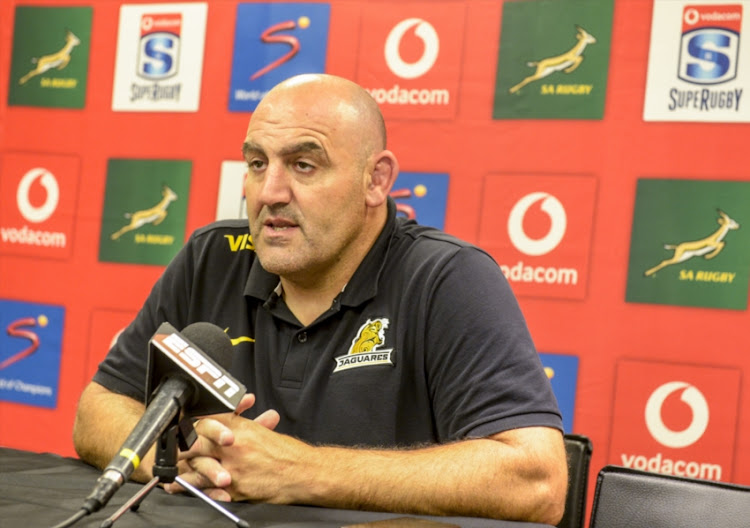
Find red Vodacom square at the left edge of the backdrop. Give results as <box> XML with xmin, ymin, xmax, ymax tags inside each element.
<box><xmin>0</xmin><ymin>153</ymin><xmax>80</xmax><ymax>258</ymax></box>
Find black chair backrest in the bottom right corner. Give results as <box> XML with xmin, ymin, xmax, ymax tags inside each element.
<box><xmin>589</xmin><ymin>466</ymin><xmax>750</xmax><ymax>528</ymax></box>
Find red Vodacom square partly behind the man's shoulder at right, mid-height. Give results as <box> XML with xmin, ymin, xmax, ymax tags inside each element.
<box><xmin>477</xmin><ymin>174</ymin><xmax>596</xmax><ymax>299</ymax></box>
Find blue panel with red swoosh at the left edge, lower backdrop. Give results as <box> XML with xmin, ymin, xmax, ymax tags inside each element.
<box><xmin>0</xmin><ymin>300</ymin><xmax>65</xmax><ymax>409</ymax></box>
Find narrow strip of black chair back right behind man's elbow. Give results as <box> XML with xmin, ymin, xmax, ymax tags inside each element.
<box><xmin>557</xmin><ymin>433</ymin><xmax>593</xmax><ymax>528</ymax></box>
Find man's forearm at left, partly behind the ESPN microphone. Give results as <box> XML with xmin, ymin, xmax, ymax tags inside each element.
<box><xmin>73</xmin><ymin>382</ymin><xmax>154</xmax><ymax>482</ymax></box>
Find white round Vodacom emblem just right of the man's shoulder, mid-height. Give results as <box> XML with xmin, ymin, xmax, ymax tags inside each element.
<box><xmin>508</xmin><ymin>192</ymin><xmax>568</xmax><ymax>256</ymax></box>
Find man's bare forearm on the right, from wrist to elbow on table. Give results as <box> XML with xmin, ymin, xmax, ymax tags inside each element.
<box><xmin>251</xmin><ymin>428</ymin><xmax>567</xmax><ymax>524</ymax></box>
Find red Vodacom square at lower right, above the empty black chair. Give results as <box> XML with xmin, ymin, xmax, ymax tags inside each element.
<box><xmin>608</xmin><ymin>360</ymin><xmax>741</xmax><ymax>481</ymax></box>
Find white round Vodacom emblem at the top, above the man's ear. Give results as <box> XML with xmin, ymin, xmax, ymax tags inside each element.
<box><xmin>385</xmin><ymin>18</ymin><xmax>440</xmax><ymax>79</ymax></box>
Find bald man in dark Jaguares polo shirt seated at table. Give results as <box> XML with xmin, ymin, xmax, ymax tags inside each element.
<box><xmin>74</xmin><ymin>75</ymin><xmax>567</xmax><ymax>524</ymax></box>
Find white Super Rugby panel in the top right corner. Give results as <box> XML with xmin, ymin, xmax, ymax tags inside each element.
<box><xmin>643</xmin><ymin>0</ymin><xmax>750</xmax><ymax>122</ymax></box>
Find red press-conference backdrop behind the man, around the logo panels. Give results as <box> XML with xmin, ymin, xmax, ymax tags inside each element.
<box><xmin>0</xmin><ymin>0</ymin><xmax>750</xmax><ymax>520</ymax></box>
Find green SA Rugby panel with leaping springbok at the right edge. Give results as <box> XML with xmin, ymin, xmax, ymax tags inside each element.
<box><xmin>626</xmin><ymin>179</ymin><xmax>750</xmax><ymax>310</ymax></box>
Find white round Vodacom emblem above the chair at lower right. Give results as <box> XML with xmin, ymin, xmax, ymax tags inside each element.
<box><xmin>646</xmin><ymin>381</ymin><xmax>708</xmax><ymax>447</ymax></box>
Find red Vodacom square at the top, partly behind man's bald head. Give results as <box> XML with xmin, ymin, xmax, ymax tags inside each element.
<box><xmin>357</xmin><ymin>2</ymin><xmax>466</xmax><ymax>119</ymax></box>
